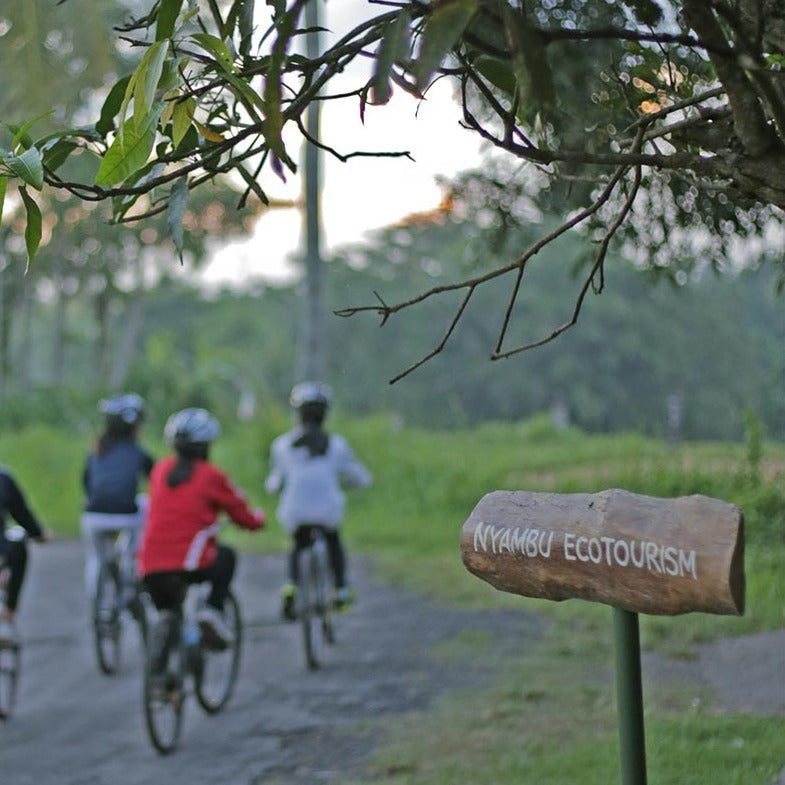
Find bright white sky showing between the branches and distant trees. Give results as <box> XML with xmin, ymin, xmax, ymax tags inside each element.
<box><xmin>203</xmin><ymin>0</ymin><xmax>481</xmax><ymax>286</ymax></box>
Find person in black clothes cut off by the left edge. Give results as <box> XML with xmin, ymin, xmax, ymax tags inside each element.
<box><xmin>0</xmin><ymin>466</ymin><xmax>52</xmax><ymax>645</ymax></box>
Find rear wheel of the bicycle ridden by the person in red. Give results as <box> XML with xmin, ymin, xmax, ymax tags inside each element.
<box><xmin>144</xmin><ymin>620</ymin><xmax>185</xmax><ymax>755</ymax></box>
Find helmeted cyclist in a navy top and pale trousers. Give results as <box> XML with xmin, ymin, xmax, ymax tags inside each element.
<box><xmin>81</xmin><ymin>393</ymin><xmax>153</xmax><ymax>600</ymax></box>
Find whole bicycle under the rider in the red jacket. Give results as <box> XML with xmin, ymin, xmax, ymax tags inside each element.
<box><xmin>144</xmin><ymin>584</ymin><xmax>242</xmax><ymax>755</ymax></box>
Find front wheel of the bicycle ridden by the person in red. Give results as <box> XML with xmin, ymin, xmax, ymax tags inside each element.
<box><xmin>193</xmin><ymin>592</ymin><xmax>243</xmax><ymax>714</ymax></box>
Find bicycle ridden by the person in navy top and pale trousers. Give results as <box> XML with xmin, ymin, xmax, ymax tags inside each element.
<box><xmin>92</xmin><ymin>529</ymin><xmax>149</xmax><ymax>676</ymax></box>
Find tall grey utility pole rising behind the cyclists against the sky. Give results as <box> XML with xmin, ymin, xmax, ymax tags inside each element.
<box><xmin>297</xmin><ymin>0</ymin><xmax>327</xmax><ymax>381</ymax></box>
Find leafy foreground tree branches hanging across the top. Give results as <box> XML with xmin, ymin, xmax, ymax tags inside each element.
<box><xmin>0</xmin><ymin>0</ymin><xmax>785</xmax><ymax>374</ymax></box>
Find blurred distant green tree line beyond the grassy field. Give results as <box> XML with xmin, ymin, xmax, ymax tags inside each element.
<box><xmin>0</xmin><ymin>208</ymin><xmax>785</xmax><ymax>439</ymax></box>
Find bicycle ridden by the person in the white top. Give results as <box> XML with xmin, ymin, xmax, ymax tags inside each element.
<box><xmin>295</xmin><ymin>525</ymin><xmax>335</xmax><ymax>670</ymax></box>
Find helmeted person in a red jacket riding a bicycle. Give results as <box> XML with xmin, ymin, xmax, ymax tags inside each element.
<box><xmin>138</xmin><ymin>409</ymin><xmax>265</xmax><ymax>652</ymax></box>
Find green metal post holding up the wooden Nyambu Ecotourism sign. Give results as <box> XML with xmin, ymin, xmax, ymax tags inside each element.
<box><xmin>613</xmin><ymin>608</ymin><xmax>646</xmax><ymax>785</ymax></box>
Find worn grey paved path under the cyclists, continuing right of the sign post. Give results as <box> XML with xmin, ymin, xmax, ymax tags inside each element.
<box><xmin>0</xmin><ymin>541</ymin><xmax>785</xmax><ymax>785</ymax></box>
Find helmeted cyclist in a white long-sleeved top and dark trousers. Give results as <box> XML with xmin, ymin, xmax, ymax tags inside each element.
<box><xmin>265</xmin><ymin>381</ymin><xmax>372</xmax><ymax>620</ymax></box>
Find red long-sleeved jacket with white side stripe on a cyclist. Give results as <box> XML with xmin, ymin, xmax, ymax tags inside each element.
<box><xmin>138</xmin><ymin>455</ymin><xmax>265</xmax><ymax>575</ymax></box>
